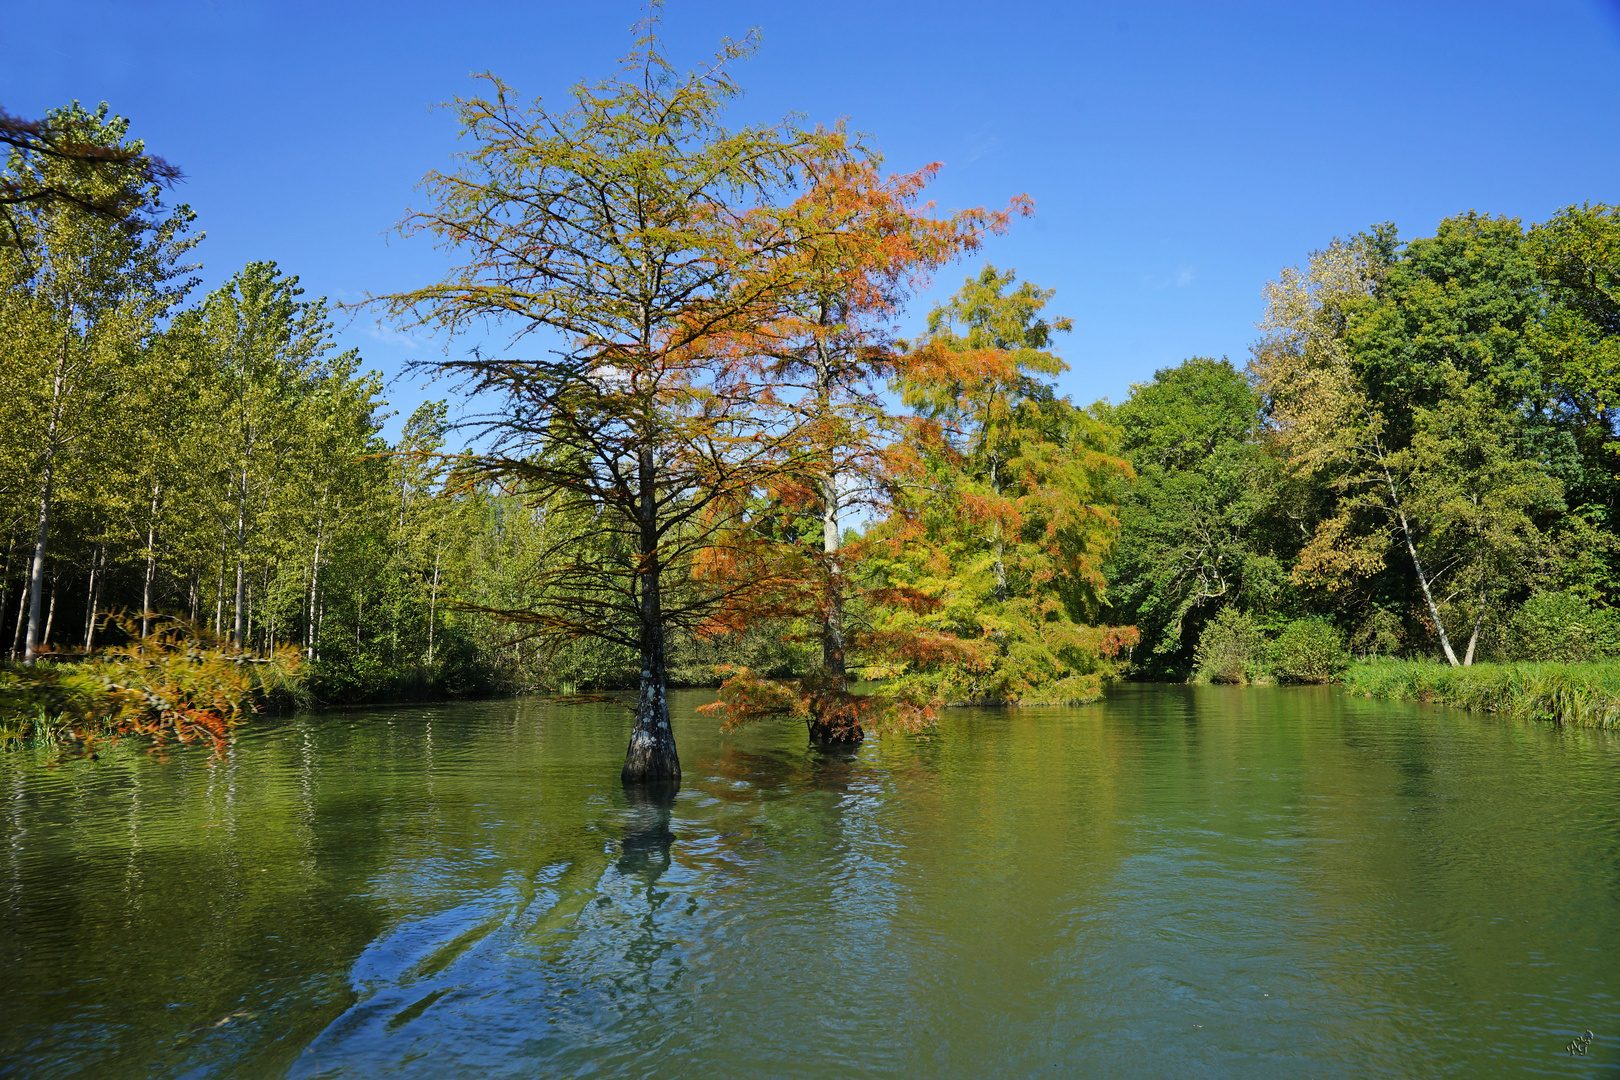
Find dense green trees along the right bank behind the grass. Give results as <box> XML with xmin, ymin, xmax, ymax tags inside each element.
<box><xmin>1097</xmin><ymin>206</ymin><xmax>1620</xmax><ymax>675</ymax></box>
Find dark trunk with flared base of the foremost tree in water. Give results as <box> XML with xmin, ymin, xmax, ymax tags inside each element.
<box><xmin>619</xmin><ymin>445</ymin><xmax>680</xmax><ymax>784</ymax></box>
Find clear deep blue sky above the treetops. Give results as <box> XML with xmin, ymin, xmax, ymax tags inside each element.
<box><xmin>0</xmin><ymin>0</ymin><xmax>1620</xmax><ymax>431</ymax></box>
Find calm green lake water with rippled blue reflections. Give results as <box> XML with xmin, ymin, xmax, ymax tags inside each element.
<box><xmin>0</xmin><ymin>687</ymin><xmax>1620</xmax><ymax>1080</ymax></box>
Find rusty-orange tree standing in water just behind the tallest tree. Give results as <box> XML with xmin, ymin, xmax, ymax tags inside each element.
<box><xmin>706</xmin><ymin>166</ymin><xmax>1030</xmax><ymax>743</ymax></box>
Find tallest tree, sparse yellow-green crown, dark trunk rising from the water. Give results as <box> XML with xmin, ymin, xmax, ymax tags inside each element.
<box><xmin>381</xmin><ymin>18</ymin><xmax>860</xmax><ymax>780</ymax></box>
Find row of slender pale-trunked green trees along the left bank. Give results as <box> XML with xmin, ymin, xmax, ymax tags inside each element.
<box><xmin>0</xmin><ymin>104</ymin><xmax>622</xmax><ymax>699</ymax></box>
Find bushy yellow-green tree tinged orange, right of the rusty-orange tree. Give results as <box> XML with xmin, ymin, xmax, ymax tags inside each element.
<box><xmin>888</xmin><ymin>266</ymin><xmax>1137</xmax><ymax>704</ymax></box>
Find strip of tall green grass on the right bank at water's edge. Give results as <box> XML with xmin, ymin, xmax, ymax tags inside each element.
<box><xmin>1345</xmin><ymin>661</ymin><xmax>1620</xmax><ymax>727</ymax></box>
